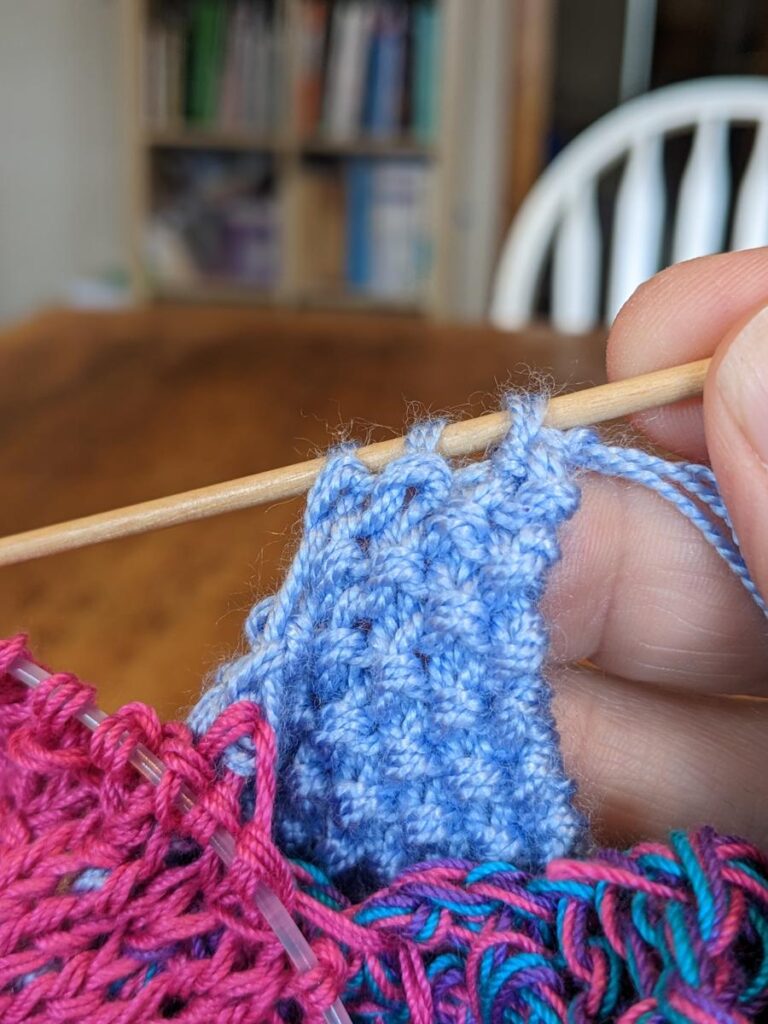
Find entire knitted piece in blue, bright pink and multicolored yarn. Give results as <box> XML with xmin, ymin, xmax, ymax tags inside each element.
<box><xmin>0</xmin><ymin>397</ymin><xmax>768</xmax><ymax>1024</ymax></box>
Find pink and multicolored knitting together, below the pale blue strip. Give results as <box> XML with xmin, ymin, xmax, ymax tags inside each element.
<box><xmin>0</xmin><ymin>638</ymin><xmax>768</xmax><ymax>1024</ymax></box>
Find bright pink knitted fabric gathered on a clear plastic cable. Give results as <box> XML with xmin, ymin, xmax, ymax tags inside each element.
<box><xmin>0</xmin><ymin>637</ymin><xmax>325</xmax><ymax>1024</ymax></box>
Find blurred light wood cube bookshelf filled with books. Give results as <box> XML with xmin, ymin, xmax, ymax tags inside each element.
<box><xmin>122</xmin><ymin>0</ymin><xmax>514</xmax><ymax>316</ymax></box>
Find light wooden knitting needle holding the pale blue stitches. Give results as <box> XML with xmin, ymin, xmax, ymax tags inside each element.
<box><xmin>0</xmin><ymin>359</ymin><xmax>710</xmax><ymax>565</ymax></box>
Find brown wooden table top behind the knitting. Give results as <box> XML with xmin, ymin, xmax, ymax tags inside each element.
<box><xmin>0</xmin><ymin>307</ymin><xmax>604</xmax><ymax>716</ymax></box>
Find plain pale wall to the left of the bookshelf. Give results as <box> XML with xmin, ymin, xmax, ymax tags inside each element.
<box><xmin>0</xmin><ymin>0</ymin><xmax>127</xmax><ymax>321</ymax></box>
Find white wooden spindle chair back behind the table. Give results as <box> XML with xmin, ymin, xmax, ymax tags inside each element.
<box><xmin>490</xmin><ymin>78</ymin><xmax>768</xmax><ymax>333</ymax></box>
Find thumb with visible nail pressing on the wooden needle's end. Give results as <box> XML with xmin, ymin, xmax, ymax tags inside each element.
<box><xmin>705</xmin><ymin>306</ymin><xmax>768</xmax><ymax>599</ymax></box>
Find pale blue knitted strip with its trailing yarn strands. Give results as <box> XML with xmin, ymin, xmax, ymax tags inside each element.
<box><xmin>190</xmin><ymin>396</ymin><xmax>760</xmax><ymax>884</ymax></box>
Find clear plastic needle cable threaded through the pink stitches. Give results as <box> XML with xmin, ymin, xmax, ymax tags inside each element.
<box><xmin>10</xmin><ymin>658</ymin><xmax>351</xmax><ymax>1024</ymax></box>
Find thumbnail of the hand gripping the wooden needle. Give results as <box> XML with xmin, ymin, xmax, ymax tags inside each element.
<box><xmin>717</xmin><ymin>306</ymin><xmax>768</xmax><ymax>464</ymax></box>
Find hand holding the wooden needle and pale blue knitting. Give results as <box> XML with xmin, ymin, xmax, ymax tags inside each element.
<box><xmin>545</xmin><ymin>249</ymin><xmax>768</xmax><ymax>847</ymax></box>
